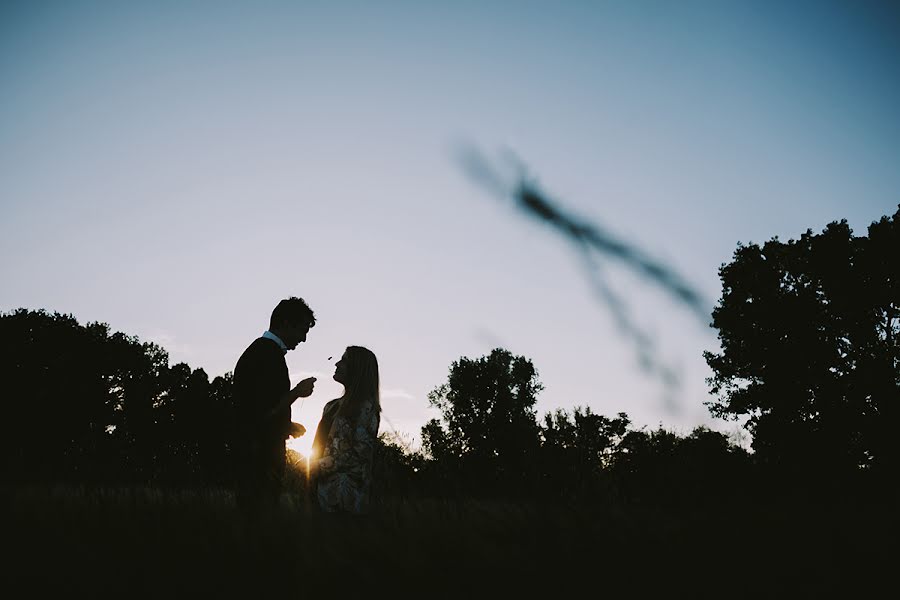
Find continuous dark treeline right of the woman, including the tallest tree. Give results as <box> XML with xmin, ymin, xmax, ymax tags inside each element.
<box><xmin>376</xmin><ymin>210</ymin><xmax>900</xmax><ymax>502</ymax></box>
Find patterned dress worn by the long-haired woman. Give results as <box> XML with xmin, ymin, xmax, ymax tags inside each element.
<box><xmin>317</xmin><ymin>401</ymin><xmax>381</xmax><ymax>514</ymax></box>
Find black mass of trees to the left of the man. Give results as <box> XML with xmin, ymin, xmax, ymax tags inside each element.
<box><xmin>0</xmin><ymin>309</ymin><xmax>231</xmax><ymax>484</ymax></box>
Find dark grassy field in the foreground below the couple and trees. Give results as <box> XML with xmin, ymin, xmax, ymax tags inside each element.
<box><xmin>0</xmin><ymin>487</ymin><xmax>900</xmax><ymax>598</ymax></box>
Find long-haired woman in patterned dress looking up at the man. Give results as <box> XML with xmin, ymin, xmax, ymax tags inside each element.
<box><xmin>310</xmin><ymin>346</ymin><xmax>381</xmax><ymax>514</ymax></box>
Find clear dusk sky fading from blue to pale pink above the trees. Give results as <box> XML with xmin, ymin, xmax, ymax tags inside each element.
<box><xmin>0</xmin><ymin>0</ymin><xmax>900</xmax><ymax>445</ymax></box>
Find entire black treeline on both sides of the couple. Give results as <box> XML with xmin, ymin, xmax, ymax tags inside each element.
<box><xmin>0</xmin><ymin>210</ymin><xmax>900</xmax><ymax>502</ymax></box>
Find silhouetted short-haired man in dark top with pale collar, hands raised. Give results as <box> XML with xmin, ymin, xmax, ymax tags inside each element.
<box><xmin>234</xmin><ymin>297</ymin><xmax>316</xmax><ymax>517</ymax></box>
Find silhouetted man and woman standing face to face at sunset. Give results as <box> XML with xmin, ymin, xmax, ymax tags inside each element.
<box><xmin>233</xmin><ymin>297</ymin><xmax>381</xmax><ymax>516</ymax></box>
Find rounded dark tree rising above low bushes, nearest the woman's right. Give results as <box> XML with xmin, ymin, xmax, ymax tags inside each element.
<box><xmin>422</xmin><ymin>348</ymin><xmax>543</xmax><ymax>489</ymax></box>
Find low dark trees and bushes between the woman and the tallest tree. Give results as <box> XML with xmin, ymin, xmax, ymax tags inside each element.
<box><xmin>416</xmin><ymin>349</ymin><xmax>753</xmax><ymax>504</ymax></box>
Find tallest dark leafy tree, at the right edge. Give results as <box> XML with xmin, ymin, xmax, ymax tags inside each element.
<box><xmin>704</xmin><ymin>210</ymin><xmax>900</xmax><ymax>472</ymax></box>
